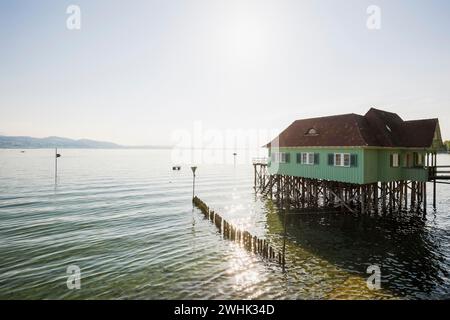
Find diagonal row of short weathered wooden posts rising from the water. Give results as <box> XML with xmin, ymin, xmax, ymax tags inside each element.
<box><xmin>193</xmin><ymin>196</ymin><xmax>285</xmax><ymax>266</ymax></box>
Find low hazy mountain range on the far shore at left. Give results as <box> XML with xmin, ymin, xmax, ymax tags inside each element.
<box><xmin>0</xmin><ymin>136</ymin><xmax>170</xmax><ymax>149</ymax></box>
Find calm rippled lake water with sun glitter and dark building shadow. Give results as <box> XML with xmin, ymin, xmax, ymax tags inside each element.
<box><xmin>0</xmin><ymin>150</ymin><xmax>450</xmax><ymax>299</ymax></box>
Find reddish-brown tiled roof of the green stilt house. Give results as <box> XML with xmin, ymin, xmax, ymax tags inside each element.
<box><xmin>267</xmin><ymin>108</ymin><xmax>438</xmax><ymax>148</ymax></box>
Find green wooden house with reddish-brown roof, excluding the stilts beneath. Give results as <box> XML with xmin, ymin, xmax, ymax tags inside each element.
<box><xmin>267</xmin><ymin>108</ymin><xmax>443</xmax><ymax>184</ymax></box>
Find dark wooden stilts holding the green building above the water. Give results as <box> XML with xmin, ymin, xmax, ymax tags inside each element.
<box><xmin>255</xmin><ymin>164</ymin><xmax>436</xmax><ymax>216</ymax></box>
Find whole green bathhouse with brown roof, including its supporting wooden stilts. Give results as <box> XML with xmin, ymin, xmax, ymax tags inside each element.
<box><xmin>255</xmin><ymin>108</ymin><xmax>443</xmax><ymax>215</ymax></box>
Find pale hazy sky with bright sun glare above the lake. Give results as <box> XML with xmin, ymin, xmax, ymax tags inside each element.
<box><xmin>0</xmin><ymin>0</ymin><xmax>450</xmax><ymax>144</ymax></box>
